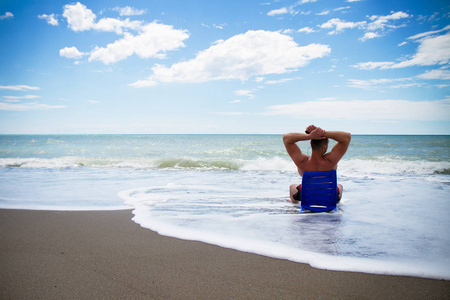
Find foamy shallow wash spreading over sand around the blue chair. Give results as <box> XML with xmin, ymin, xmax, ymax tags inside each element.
<box><xmin>121</xmin><ymin>171</ymin><xmax>450</xmax><ymax>280</ymax></box>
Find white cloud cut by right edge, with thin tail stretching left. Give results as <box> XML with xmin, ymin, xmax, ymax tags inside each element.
<box><xmin>353</xmin><ymin>33</ymin><xmax>450</xmax><ymax>70</ymax></box>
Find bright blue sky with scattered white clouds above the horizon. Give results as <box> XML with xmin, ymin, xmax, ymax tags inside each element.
<box><xmin>0</xmin><ymin>0</ymin><xmax>450</xmax><ymax>134</ymax></box>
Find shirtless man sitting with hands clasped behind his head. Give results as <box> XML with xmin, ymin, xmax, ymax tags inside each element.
<box><xmin>283</xmin><ymin>125</ymin><xmax>351</xmax><ymax>203</ymax></box>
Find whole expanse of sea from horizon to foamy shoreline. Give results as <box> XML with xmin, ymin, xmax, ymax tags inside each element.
<box><xmin>0</xmin><ymin>135</ymin><xmax>450</xmax><ymax>280</ymax></box>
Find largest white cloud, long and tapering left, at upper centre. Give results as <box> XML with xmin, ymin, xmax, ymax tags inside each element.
<box><xmin>131</xmin><ymin>30</ymin><xmax>331</xmax><ymax>87</ymax></box>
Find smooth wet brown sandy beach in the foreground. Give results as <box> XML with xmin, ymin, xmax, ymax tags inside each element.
<box><xmin>0</xmin><ymin>210</ymin><xmax>450</xmax><ymax>299</ymax></box>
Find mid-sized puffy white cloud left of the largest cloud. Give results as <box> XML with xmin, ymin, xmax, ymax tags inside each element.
<box><xmin>89</xmin><ymin>22</ymin><xmax>189</xmax><ymax>64</ymax></box>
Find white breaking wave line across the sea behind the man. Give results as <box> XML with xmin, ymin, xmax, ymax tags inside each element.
<box><xmin>0</xmin><ymin>156</ymin><xmax>450</xmax><ymax>177</ymax></box>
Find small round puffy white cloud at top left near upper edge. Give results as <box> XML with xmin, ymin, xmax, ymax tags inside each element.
<box><xmin>63</xmin><ymin>2</ymin><xmax>96</xmax><ymax>31</ymax></box>
